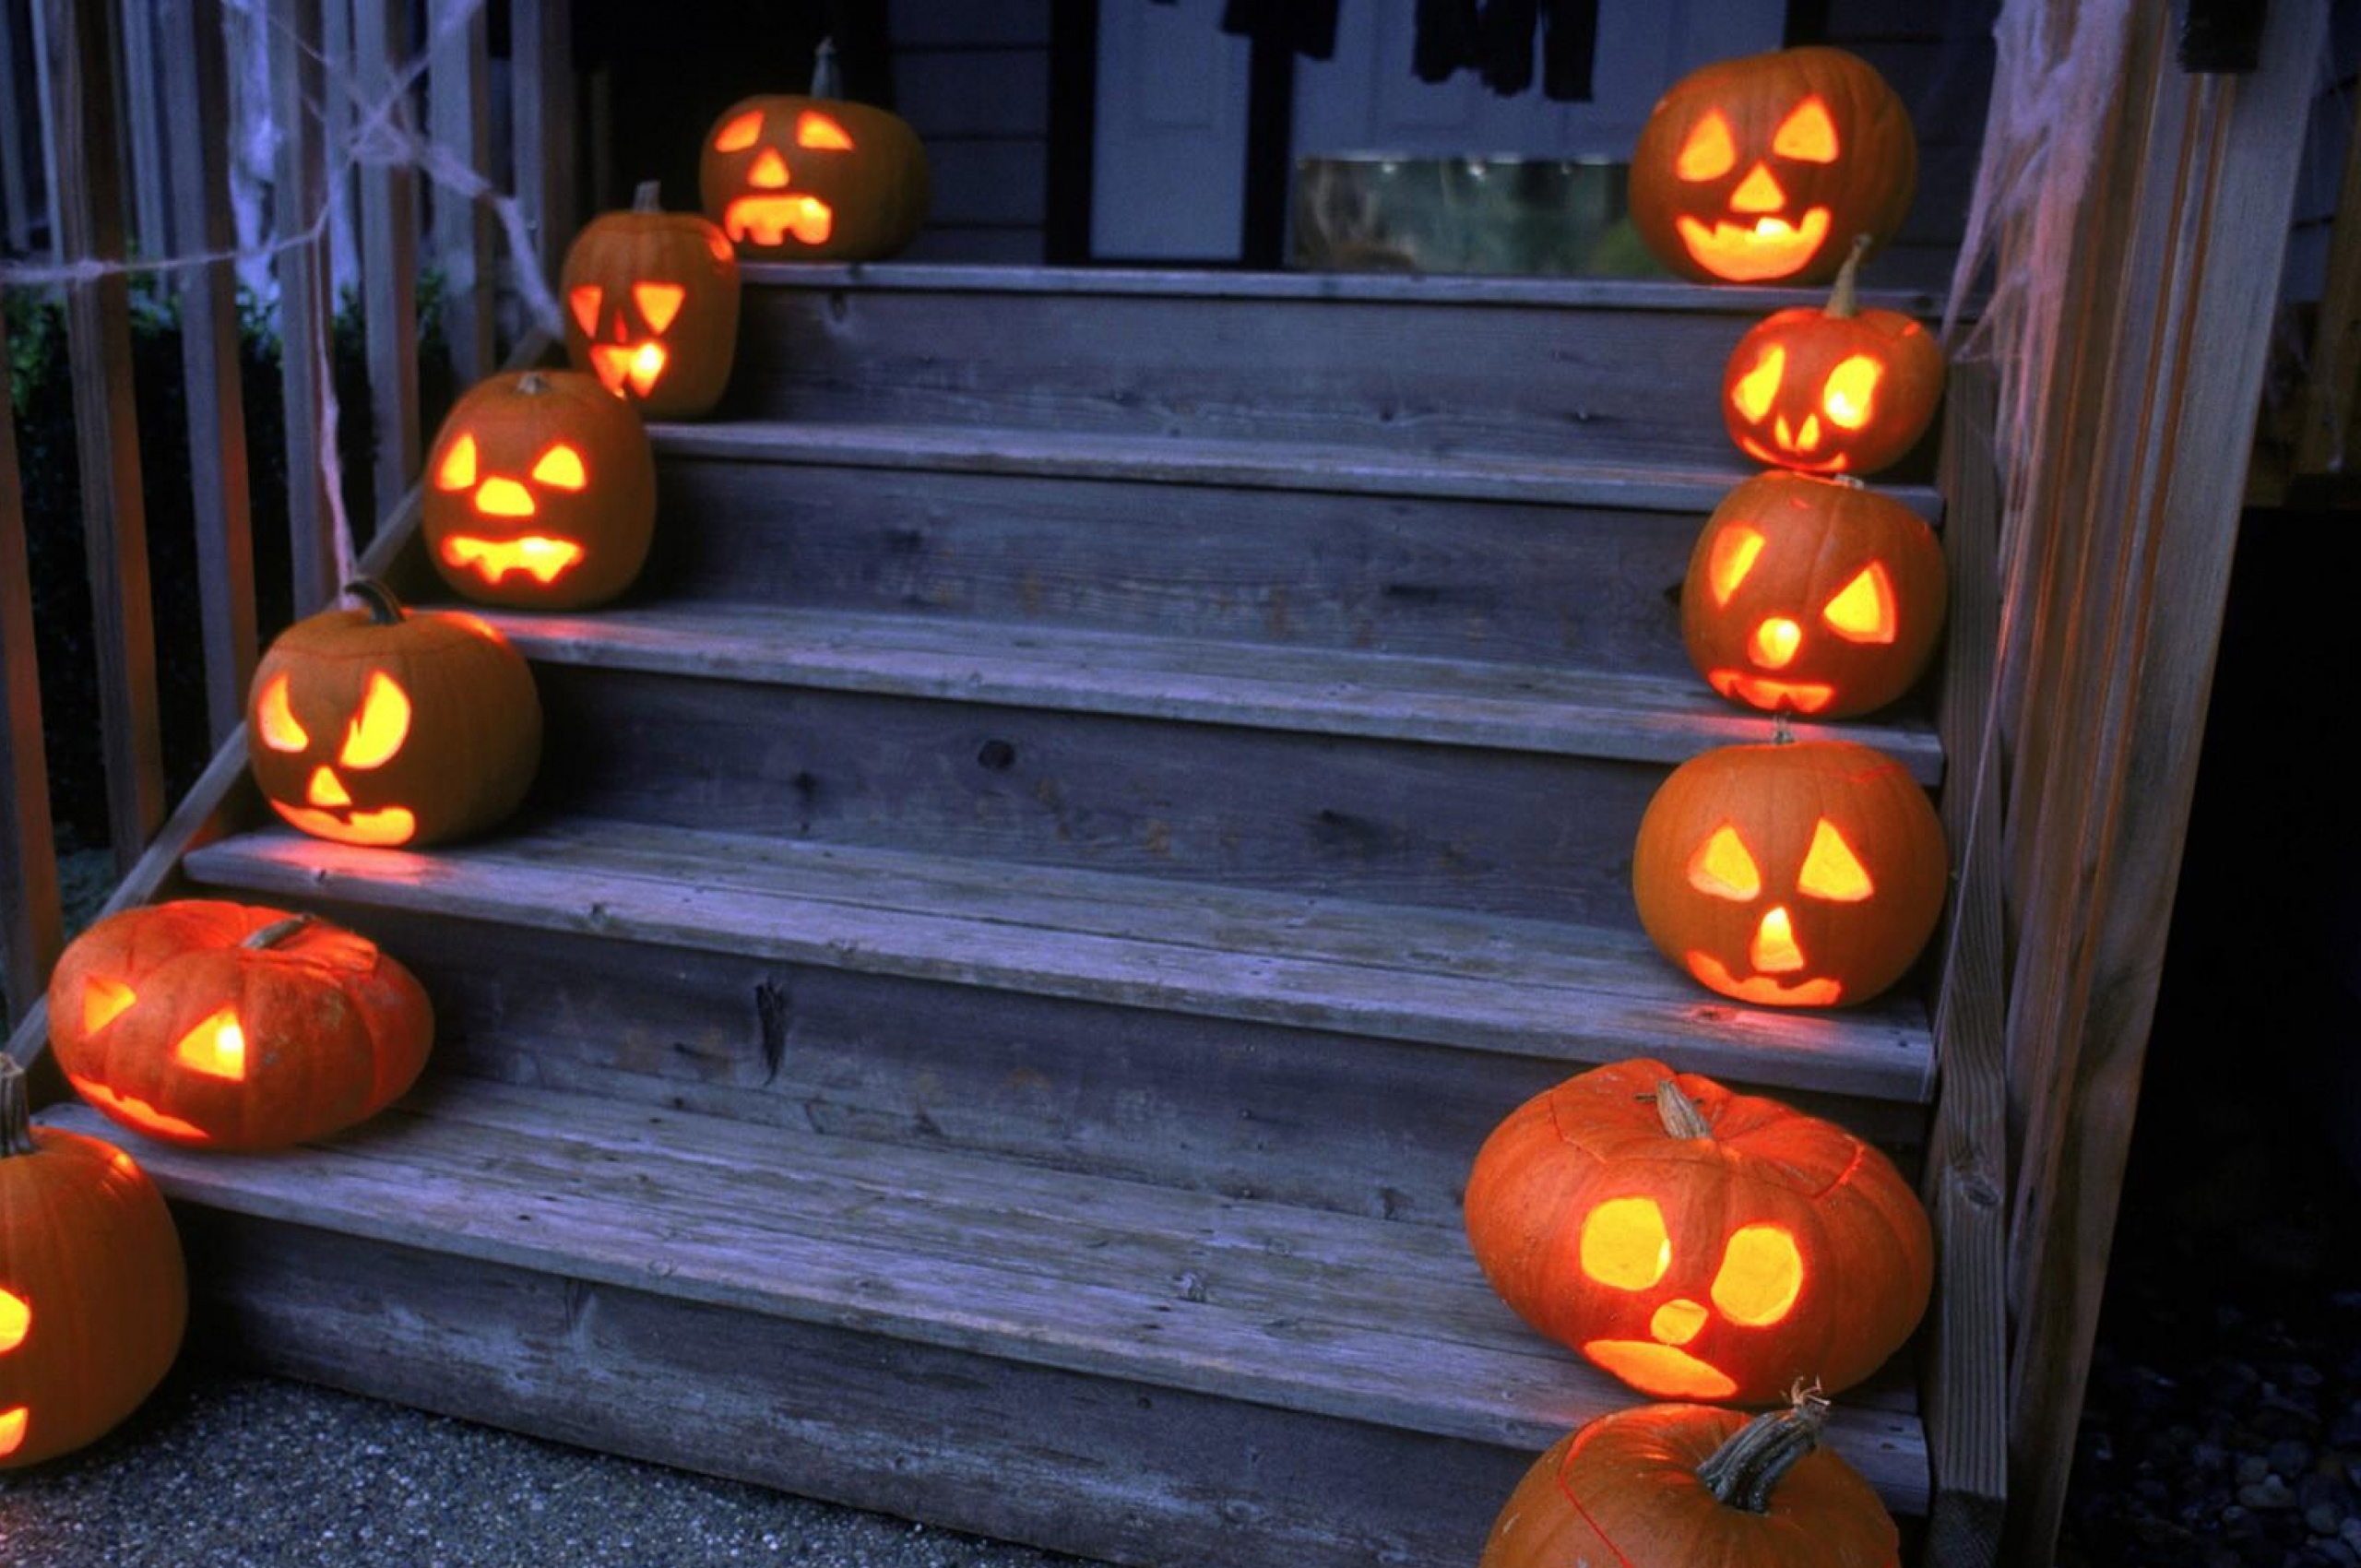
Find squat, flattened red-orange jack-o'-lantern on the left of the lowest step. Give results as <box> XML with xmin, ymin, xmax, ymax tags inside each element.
<box><xmin>50</xmin><ymin>899</ymin><xmax>434</xmax><ymax>1150</ymax></box>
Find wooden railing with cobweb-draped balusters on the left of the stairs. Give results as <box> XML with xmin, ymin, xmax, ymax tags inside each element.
<box><xmin>0</xmin><ymin>0</ymin><xmax>574</xmax><ymax>1028</ymax></box>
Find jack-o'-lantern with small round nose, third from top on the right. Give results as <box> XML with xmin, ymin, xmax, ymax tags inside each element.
<box><xmin>1681</xmin><ymin>469</ymin><xmax>1948</xmax><ymax>718</ymax></box>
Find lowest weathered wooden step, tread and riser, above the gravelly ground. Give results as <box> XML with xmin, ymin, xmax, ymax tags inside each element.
<box><xmin>28</xmin><ymin>1082</ymin><xmax>1929</xmax><ymax>1568</ymax></box>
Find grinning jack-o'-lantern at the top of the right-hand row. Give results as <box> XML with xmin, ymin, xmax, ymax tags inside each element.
<box><xmin>1629</xmin><ymin>45</ymin><xmax>1917</xmax><ymax>283</ymax></box>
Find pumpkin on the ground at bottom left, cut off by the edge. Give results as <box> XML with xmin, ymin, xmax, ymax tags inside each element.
<box><xmin>0</xmin><ymin>1055</ymin><xmax>189</xmax><ymax>1468</ymax></box>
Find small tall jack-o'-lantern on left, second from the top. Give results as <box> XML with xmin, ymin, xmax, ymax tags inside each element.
<box><xmin>557</xmin><ymin>180</ymin><xmax>739</xmax><ymax>421</ymax></box>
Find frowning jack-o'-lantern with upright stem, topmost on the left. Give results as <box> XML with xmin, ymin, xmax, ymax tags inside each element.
<box><xmin>696</xmin><ymin>42</ymin><xmax>928</xmax><ymax>262</ymax></box>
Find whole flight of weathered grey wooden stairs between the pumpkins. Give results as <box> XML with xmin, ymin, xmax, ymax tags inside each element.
<box><xmin>47</xmin><ymin>267</ymin><xmax>1943</xmax><ymax>1568</ymax></box>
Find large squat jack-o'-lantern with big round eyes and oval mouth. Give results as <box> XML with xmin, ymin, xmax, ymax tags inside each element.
<box><xmin>1466</xmin><ymin>1061</ymin><xmax>1934</xmax><ymax>1403</ymax></box>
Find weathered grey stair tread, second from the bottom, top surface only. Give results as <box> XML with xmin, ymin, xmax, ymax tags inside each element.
<box><xmin>189</xmin><ymin>826</ymin><xmax>1931</xmax><ymax>1114</ymax></box>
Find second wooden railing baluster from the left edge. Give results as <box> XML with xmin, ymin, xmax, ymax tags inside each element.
<box><xmin>33</xmin><ymin>0</ymin><xmax>165</xmax><ymax>872</ymax></box>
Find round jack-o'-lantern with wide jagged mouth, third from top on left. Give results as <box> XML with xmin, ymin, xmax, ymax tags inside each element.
<box><xmin>418</xmin><ymin>371</ymin><xmax>657</xmax><ymax>610</ymax></box>
